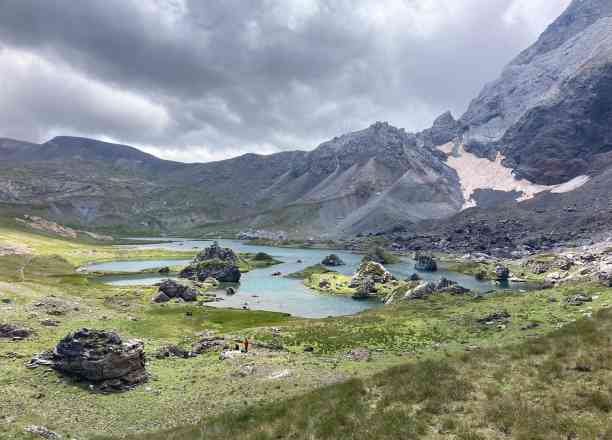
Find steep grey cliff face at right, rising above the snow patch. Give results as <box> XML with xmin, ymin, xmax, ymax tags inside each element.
<box><xmin>460</xmin><ymin>0</ymin><xmax>612</xmax><ymax>185</ymax></box>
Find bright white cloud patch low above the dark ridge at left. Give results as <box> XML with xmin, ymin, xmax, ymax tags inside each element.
<box><xmin>0</xmin><ymin>48</ymin><xmax>170</xmax><ymax>143</ymax></box>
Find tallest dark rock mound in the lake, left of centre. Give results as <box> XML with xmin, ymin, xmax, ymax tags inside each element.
<box><xmin>179</xmin><ymin>242</ymin><xmax>241</xmax><ymax>283</ymax></box>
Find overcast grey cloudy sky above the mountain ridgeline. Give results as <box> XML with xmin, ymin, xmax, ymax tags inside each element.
<box><xmin>0</xmin><ymin>0</ymin><xmax>570</xmax><ymax>162</ymax></box>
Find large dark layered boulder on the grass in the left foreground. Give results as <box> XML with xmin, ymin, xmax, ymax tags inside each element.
<box><xmin>32</xmin><ymin>328</ymin><xmax>149</xmax><ymax>391</ymax></box>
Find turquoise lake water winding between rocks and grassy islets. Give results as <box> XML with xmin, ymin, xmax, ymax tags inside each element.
<box><xmin>86</xmin><ymin>240</ymin><xmax>520</xmax><ymax>318</ymax></box>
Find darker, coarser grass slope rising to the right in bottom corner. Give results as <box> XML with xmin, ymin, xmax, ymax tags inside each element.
<box><xmin>129</xmin><ymin>310</ymin><xmax>612</xmax><ymax>440</ymax></box>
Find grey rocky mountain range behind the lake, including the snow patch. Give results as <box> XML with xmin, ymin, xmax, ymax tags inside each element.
<box><xmin>0</xmin><ymin>0</ymin><xmax>612</xmax><ymax>238</ymax></box>
